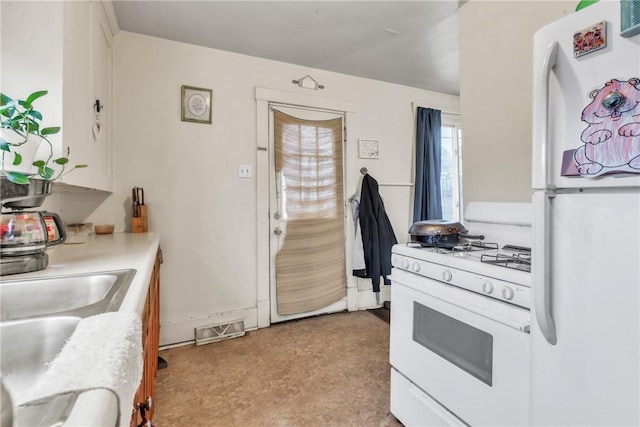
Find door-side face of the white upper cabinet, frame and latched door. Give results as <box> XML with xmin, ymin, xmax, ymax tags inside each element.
<box><xmin>62</xmin><ymin>1</ymin><xmax>113</xmax><ymax>191</ymax></box>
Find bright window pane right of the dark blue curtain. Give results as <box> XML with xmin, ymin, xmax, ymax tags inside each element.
<box><xmin>440</xmin><ymin>113</ymin><xmax>462</xmax><ymax>221</ymax></box>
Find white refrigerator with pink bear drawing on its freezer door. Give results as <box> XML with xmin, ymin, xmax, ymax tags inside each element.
<box><xmin>530</xmin><ymin>0</ymin><xmax>640</xmax><ymax>426</ymax></box>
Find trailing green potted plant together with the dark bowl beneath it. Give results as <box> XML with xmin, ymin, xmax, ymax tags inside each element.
<box><xmin>0</xmin><ymin>90</ymin><xmax>87</xmax><ymax>209</ymax></box>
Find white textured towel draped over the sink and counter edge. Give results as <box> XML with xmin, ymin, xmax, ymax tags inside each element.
<box><xmin>32</xmin><ymin>312</ymin><xmax>143</xmax><ymax>427</ymax></box>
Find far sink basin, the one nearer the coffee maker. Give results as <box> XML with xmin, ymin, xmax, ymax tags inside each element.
<box><xmin>0</xmin><ymin>270</ymin><xmax>135</xmax><ymax>320</ymax></box>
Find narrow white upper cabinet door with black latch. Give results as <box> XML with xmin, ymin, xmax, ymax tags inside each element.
<box><xmin>90</xmin><ymin>1</ymin><xmax>113</xmax><ymax>191</ymax></box>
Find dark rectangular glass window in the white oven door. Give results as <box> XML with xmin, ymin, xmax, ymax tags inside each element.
<box><xmin>413</xmin><ymin>301</ymin><xmax>493</xmax><ymax>386</ymax></box>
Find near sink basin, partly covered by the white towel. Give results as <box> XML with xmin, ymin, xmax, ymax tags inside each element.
<box><xmin>0</xmin><ymin>316</ymin><xmax>81</xmax><ymax>405</ymax></box>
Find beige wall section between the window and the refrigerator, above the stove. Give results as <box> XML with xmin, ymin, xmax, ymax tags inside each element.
<box><xmin>459</xmin><ymin>0</ymin><xmax>578</xmax><ymax>206</ymax></box>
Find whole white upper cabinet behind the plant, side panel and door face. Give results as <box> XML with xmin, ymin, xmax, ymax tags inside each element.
<box><xmin>1</xmin><ymin>0</ymin><xmax>113</xmax><ymax>191</ymax></box>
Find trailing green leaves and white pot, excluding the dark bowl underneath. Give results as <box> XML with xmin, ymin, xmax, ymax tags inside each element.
<box><xmin>0</xmin><ymin>90</ymin><xmax>87</xmax><ymax>184</ymax></box>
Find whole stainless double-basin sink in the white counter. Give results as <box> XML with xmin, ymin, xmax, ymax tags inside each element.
<box><xmin>0</xmin><ymin>270</ymin><xmax>136</xmax><ymax>412</ymax></box>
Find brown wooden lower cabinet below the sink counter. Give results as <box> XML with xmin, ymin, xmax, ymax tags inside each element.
<box><xmin>130</xmin><ymin>249</ymin><xmax>162</xmax><ymax>427</ymax></box>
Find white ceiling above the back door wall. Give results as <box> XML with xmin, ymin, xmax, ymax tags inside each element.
<box><xmin>113</xmin><ymin>0</ymin><xmax>459</xmax><ymax>95</ymax></box>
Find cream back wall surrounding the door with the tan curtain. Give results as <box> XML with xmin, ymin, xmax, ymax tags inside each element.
<box><xmin>54</xmin><ymin>32</ymin><xmax>459</xmax><ymax>344</ymax></box>
